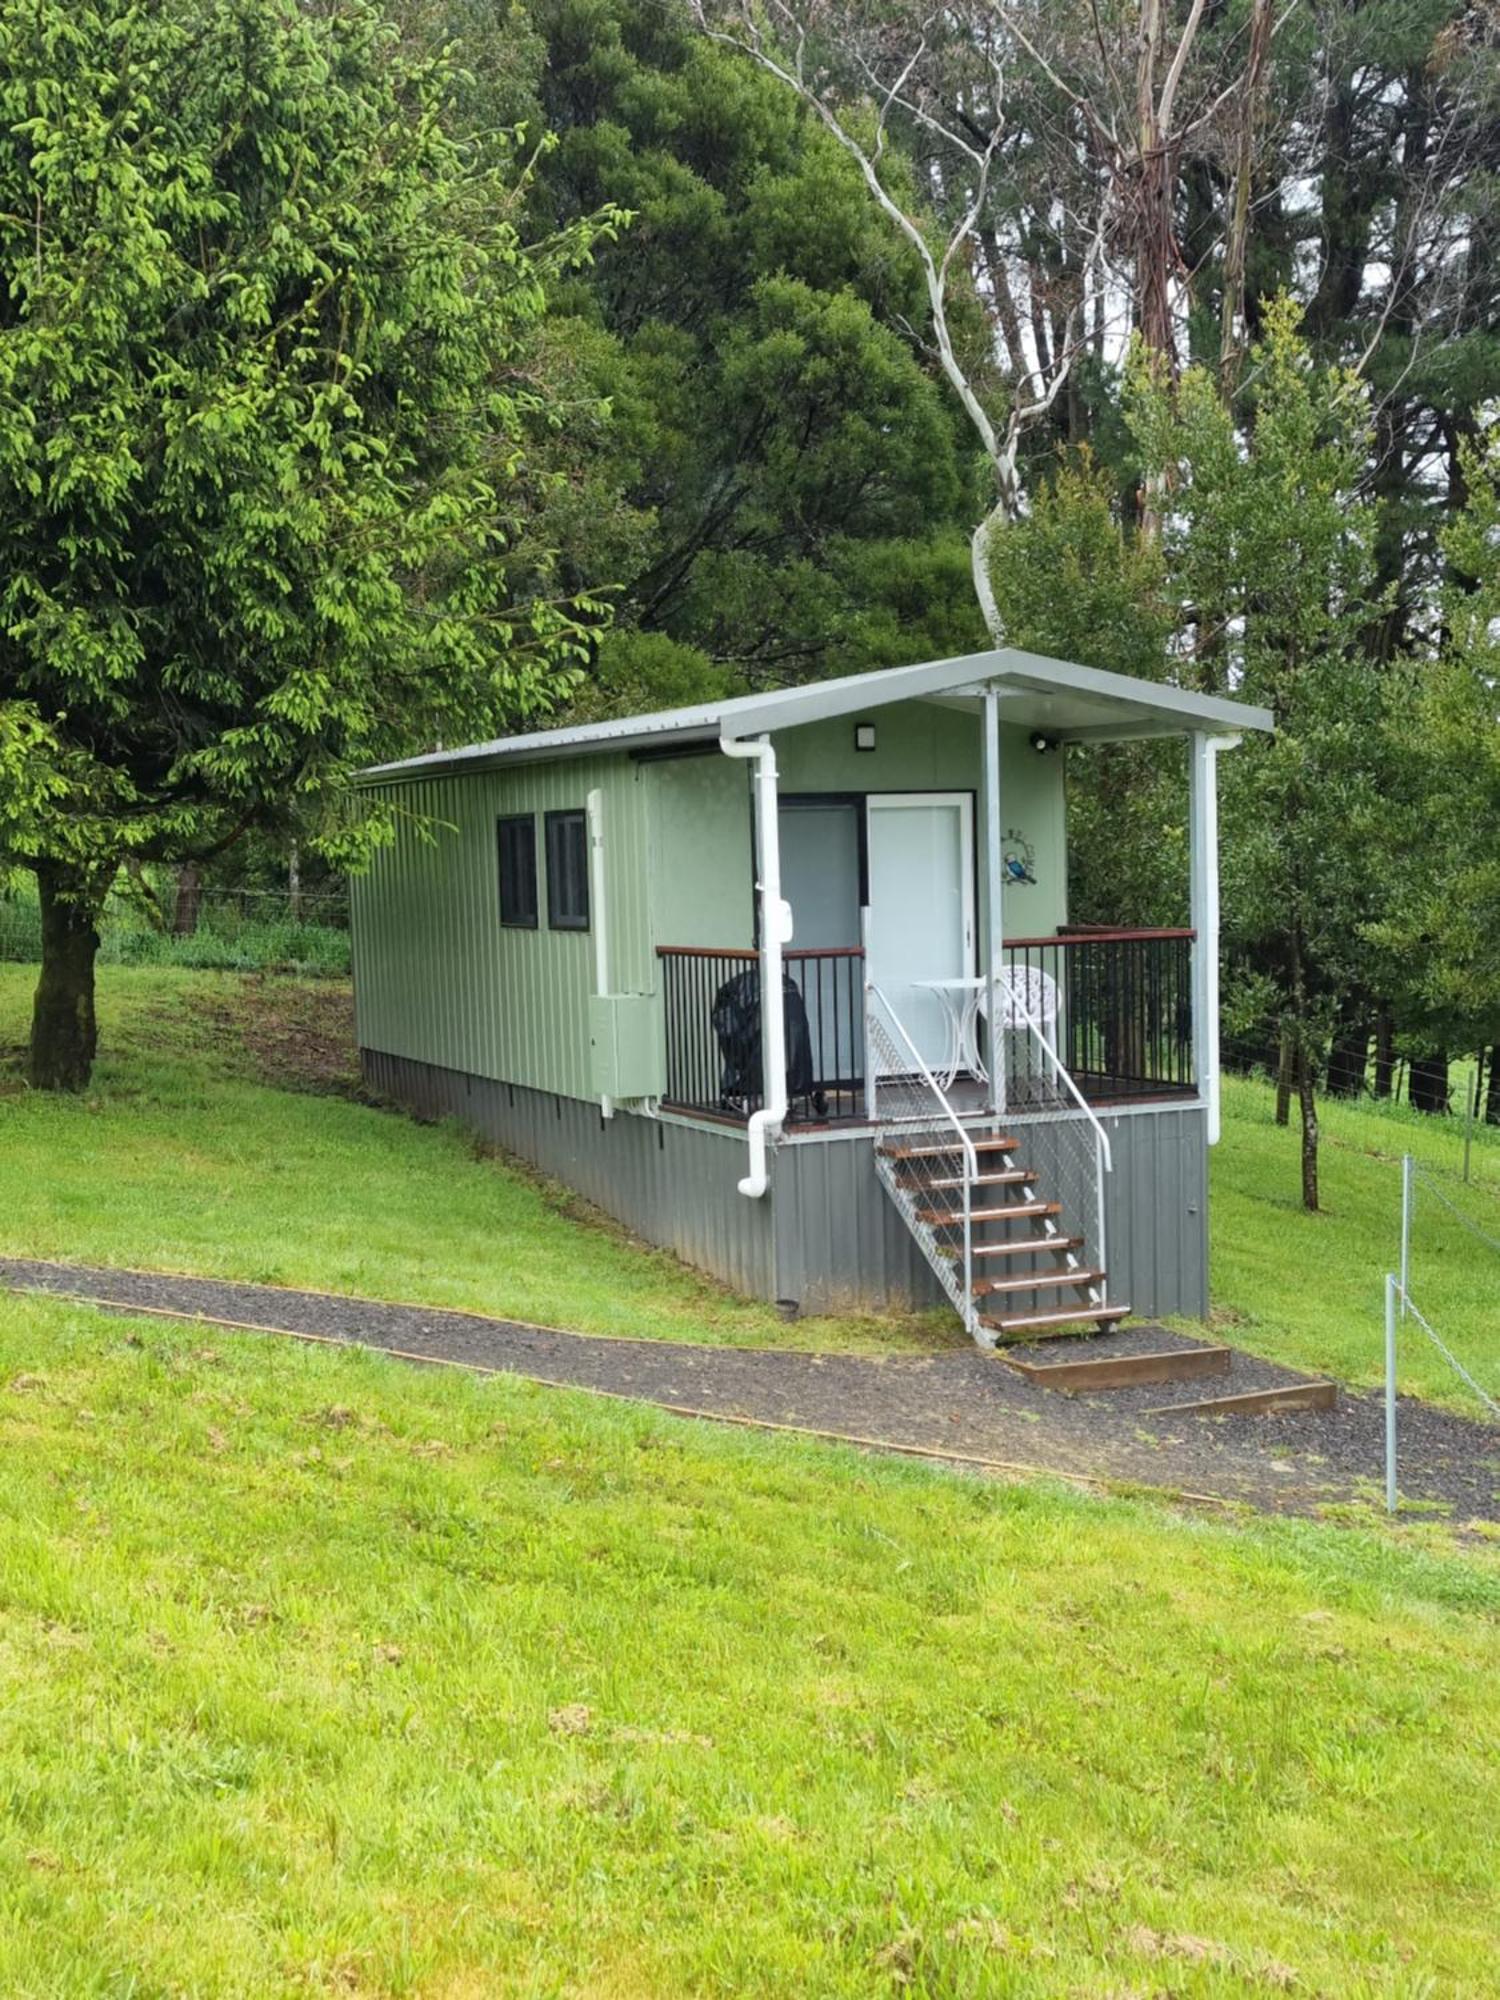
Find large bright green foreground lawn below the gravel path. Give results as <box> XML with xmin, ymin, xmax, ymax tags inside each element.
<box><xmin>0</xmin><ymin>1298</ymin><xmax>1500</xmax><ymax>2000</ymax></box>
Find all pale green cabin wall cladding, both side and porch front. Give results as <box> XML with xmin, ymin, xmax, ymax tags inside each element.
<box><xmin>354</xmin><ymin>702</ymin><xmax>1068</xmax><ymax>1098</ymax></box>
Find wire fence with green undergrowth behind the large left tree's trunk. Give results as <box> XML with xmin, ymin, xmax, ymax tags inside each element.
<box><xmin>0</xmin><ymin>882</ymin><xmax>350</xmax><ymax>978</ymax></box>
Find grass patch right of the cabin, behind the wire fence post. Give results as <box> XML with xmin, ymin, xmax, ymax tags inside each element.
<box><xmin>1210</xmin><ymin>1078</ymin><xmax>1500</xmax><ymax>1416</ymax></box>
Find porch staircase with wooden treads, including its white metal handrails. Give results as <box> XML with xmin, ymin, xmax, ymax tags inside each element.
<box><xmin>866</xmin><ymin>986</ymin><xmax>1130</xmax><ymax>1348</ymax></box>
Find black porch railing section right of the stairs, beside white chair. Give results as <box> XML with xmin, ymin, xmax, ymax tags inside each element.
<box><xmin>1006</xmin><ymin>930</ymin><xmax>1196</xmax><ymax>1104</ymax></box>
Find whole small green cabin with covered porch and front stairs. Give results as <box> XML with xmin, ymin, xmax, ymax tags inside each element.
<box><xmin>354</xmin><ymin>648</ymin><xmax>1270</xmax><ymax>1344</ymax></box>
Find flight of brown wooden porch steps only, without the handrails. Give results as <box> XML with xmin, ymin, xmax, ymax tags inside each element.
<box><xmin>876</xmin><ymin>1126</ymin><xmax>1130</xmax><ymax>1346</ymax></box>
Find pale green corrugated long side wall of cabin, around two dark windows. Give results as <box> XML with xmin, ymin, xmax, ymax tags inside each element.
<box><xmin>354</xmin><ymin>756</ymin><xmax>654</xmax><ymax>1098</ymax></box>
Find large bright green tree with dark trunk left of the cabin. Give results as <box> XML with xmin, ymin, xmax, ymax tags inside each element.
<box><xmin>0</xmin><ymin>0</ymin><xmax>612</xmax><ymax>1088</ymax></box>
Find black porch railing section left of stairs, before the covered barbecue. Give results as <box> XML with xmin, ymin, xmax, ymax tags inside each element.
<box><xmin>656</xmin><ymin>944</ymin><xmax>864</xmax><ymax>1124</ymax></box>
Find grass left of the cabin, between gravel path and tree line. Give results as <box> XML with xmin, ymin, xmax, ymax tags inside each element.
<box><xmin>0</xmin><ymin>966</ymin><xmax>952</xmax><ymax>1352</ymax></box>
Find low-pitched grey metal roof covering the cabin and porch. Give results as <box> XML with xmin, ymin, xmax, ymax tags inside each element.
<box><xmin>360</xmin><ymin>646</ymin><xmax>1272</xmax><ymax>784</ymax></box>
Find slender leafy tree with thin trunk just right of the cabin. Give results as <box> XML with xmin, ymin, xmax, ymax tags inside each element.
<box><xmin>1128</xmin><ymin>298</ymin><xmax>1388</xmax><ymax>1208</ymax></box>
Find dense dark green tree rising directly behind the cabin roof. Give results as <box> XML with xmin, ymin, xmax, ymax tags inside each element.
<box><xmin>530</xmin><ymin>0</ymin><xmax>982</xmax><ymax>710</ymax></box>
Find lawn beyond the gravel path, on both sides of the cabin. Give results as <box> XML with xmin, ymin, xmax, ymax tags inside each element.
<box><xmin>0</xmin><ymin>966</ymin><xmax>1500</xmax><ymax>1414</ymax></box>
